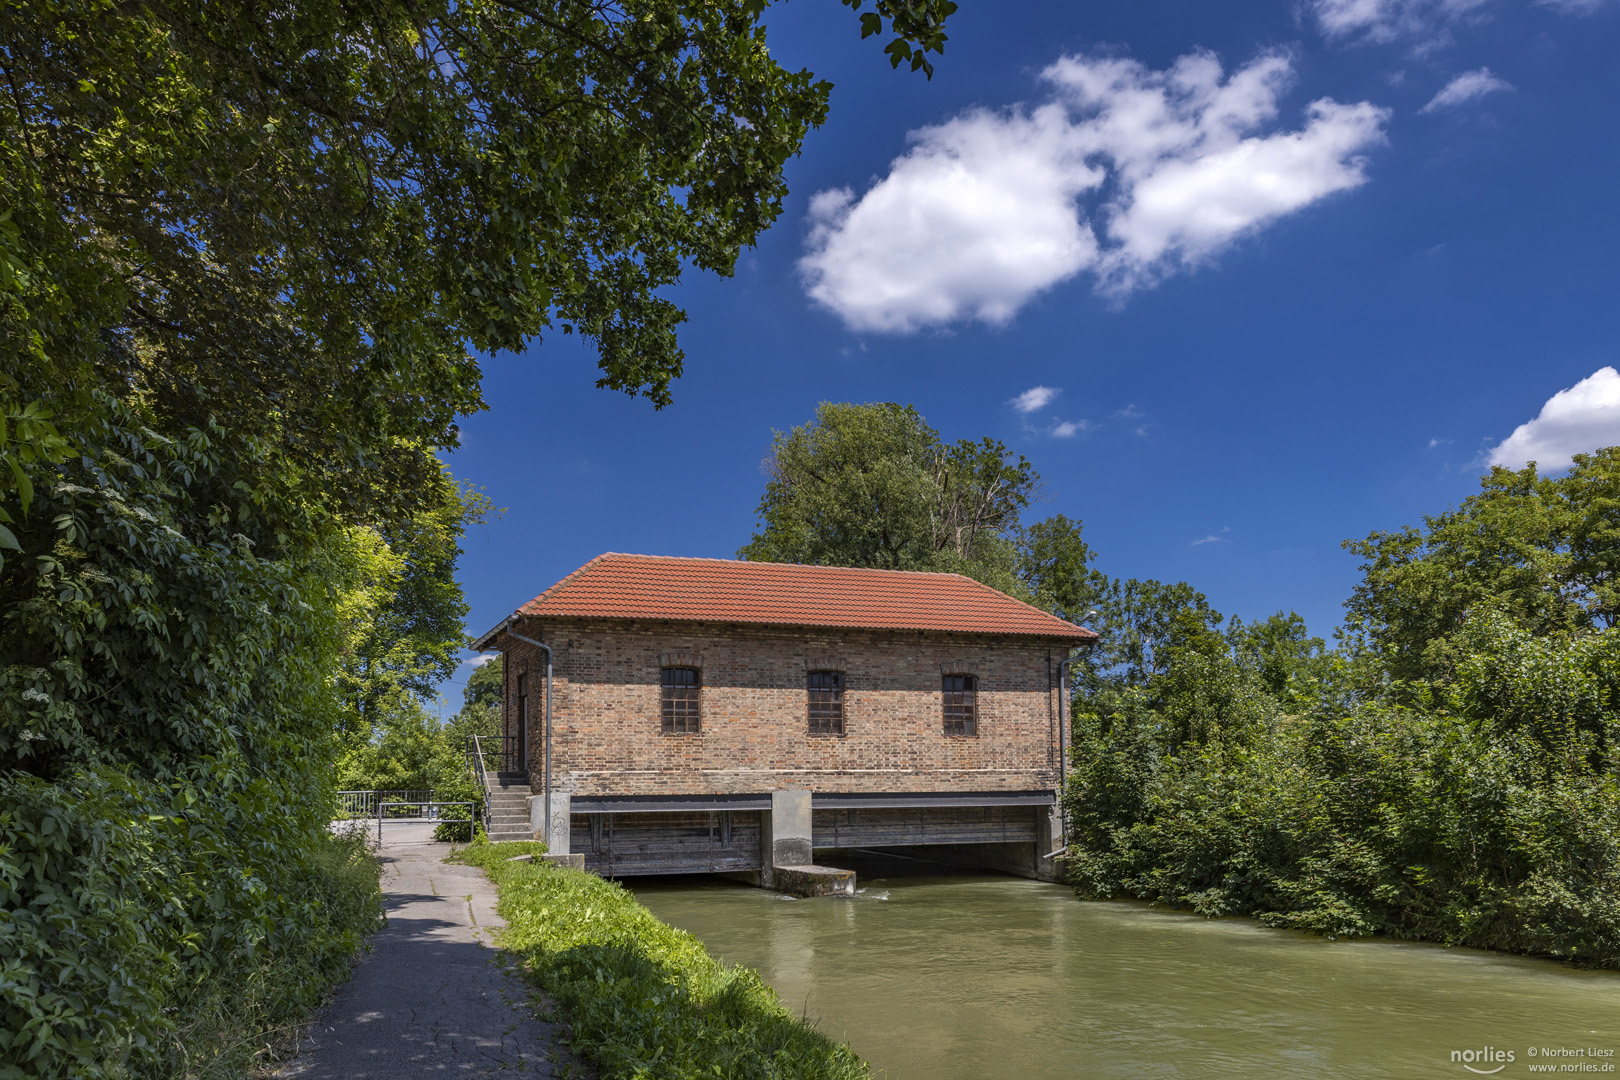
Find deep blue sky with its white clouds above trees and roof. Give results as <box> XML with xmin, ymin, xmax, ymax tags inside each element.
<box><xmin>446</xmin><ymin>0</ymin><xmax>1620</xmax><ymax>709</ymax></box>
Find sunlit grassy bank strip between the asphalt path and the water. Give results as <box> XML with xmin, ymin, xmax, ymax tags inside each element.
<box><xmin>452</xmin><ymin>844</ymin><xmax>870</xmax><ymax>1080</ymax></box>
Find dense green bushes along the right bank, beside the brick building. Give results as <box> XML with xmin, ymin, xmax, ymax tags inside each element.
<box><xmin>1066</xmin><ymin>617</ymin><xmax>1620</xmax><ymax>968</ymax></box>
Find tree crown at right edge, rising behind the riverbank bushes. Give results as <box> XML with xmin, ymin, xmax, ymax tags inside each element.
<box><xmin>1345</xmin><ymin>447</ymin><xmax>1620</xmax><ymax>682</ymax></box>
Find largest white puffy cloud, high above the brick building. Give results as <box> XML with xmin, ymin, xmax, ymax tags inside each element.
<box><xmin>799</xmin><ymin>52</ymin><xmax>1388</xmax><ymax>334</ymax></box>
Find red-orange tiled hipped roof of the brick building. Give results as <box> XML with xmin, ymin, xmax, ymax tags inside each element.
<box><xmin>498</xmin><ymin>552</ymin><xmax>1097</xmax><ymax>641</ymax></box>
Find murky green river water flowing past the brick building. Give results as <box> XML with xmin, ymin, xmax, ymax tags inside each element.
<box><xmin>629</xmin><ymin>863</ymin><xmax>1620</xmax><ymax>1080</ymax></box>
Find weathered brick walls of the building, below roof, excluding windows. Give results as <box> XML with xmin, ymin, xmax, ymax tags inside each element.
<box><xmin>497</xmin><ymin>619</ymin><xmax>1068</xmax><ymax>795</ymax></box>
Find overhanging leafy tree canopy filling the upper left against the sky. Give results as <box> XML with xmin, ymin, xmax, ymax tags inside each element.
<box><xmin>0</xmin><ymin>0</ymin><xmax>954</xmax><ymax>420</ymax></box>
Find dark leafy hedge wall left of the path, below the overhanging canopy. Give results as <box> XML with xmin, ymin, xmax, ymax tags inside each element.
<box><xmin>0</xmin><ymin>402</ymin><xmax>381</xmax><ymax>1077</ymax></box>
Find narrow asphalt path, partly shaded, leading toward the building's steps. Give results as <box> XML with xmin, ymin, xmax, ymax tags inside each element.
<box><xmin>275</xmin><ymin>823</ymin><xmax>578</xmax><ymax>1080</ymax></box>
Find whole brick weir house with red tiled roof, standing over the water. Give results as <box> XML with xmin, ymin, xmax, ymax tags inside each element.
<box><xmin>475</xmin><ymin>554</ymin><xmax>1097</xmax><ymax>895</ymax></box>
